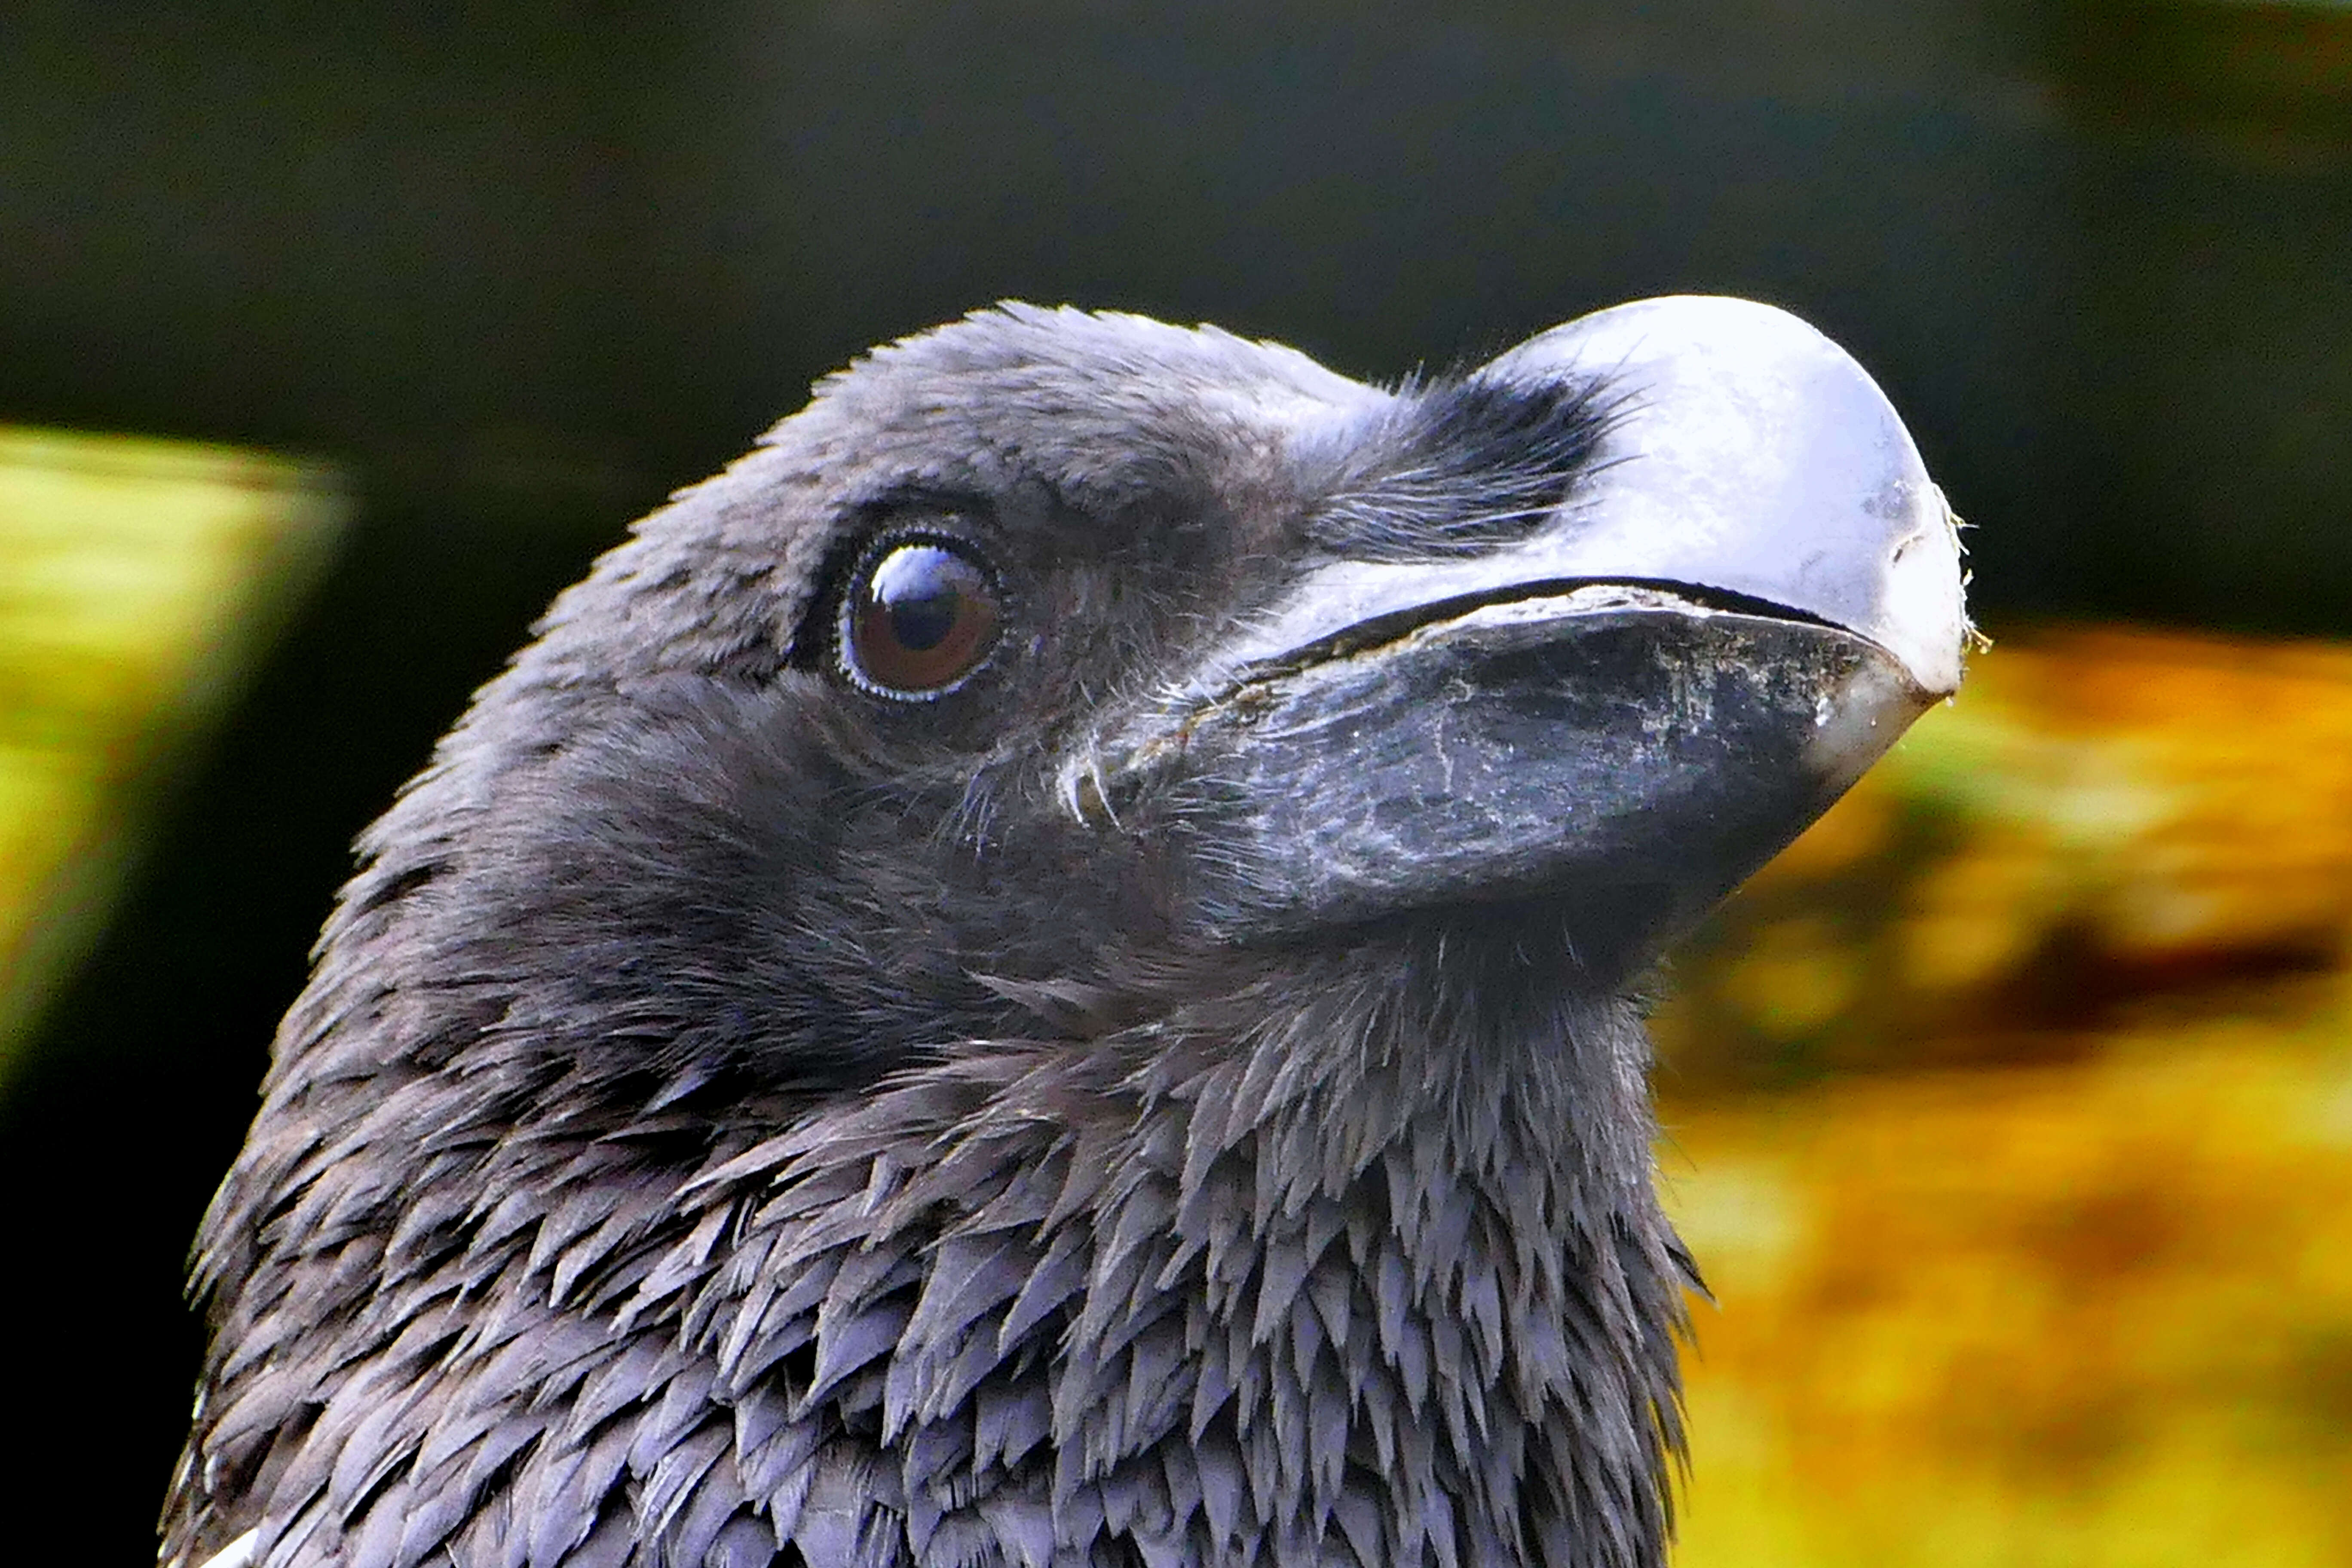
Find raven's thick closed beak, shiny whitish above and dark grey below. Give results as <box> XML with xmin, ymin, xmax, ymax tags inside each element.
<box><xmin>1101</xmin><ymin>299</ymin><xmax>1969</xmax><ymax>973</ymax></box>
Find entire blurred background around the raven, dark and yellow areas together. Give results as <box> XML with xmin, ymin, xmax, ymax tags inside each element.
<box><xmin>0</xmin><ymin>0</ymin><xmax>2352</xmax><ymax>1568</ymax></box>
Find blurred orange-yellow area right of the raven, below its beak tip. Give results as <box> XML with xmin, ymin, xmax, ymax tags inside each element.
<box><xmin>1660</xmin><ymin>632</ymin><xmax>2352</xmax><ymax>1568</ymax></box>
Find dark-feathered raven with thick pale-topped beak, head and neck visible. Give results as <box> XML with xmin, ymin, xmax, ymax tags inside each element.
<box><xmin>162</xmin><ymin>299</ymin><xmax>1969</xmax><ymax>1568</ymax></box>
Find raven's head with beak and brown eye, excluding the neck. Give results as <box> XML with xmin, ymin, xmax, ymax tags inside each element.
<box><xmin>322</xmin><ymin>299</ymin><xmax>1966</xmax><ymax>1093</ymax></box>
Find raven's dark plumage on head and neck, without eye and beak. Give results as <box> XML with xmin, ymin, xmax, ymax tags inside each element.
<box><xmin>165</xmin><ymin>308</ymin><xmax>1691</xmax><ymax>1568</ymax></box>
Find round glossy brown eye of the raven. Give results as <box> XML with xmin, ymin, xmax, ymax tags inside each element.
<box><xmin>842</xmin><ymin>538</ymin><xmax>1002</xmax><ymax>698</ymax></box>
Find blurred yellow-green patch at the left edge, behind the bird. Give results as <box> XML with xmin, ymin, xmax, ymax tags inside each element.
<box><xmin>0</xmin><ymin>426</ymin><xmax>341</xmax><ymax>1084</ymax></box>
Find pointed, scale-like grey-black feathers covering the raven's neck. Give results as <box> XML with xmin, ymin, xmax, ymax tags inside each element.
<box><xmin>172</xmin><ymin>964</ymin><xmax>1684</xmax><ymax>1568</ymax></box>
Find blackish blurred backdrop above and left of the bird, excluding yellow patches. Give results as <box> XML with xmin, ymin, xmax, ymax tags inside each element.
<box><xmin>0</xmin><ymin>0</ymin><xmax>2352</xmax><ymax>1563</ymax></box>
